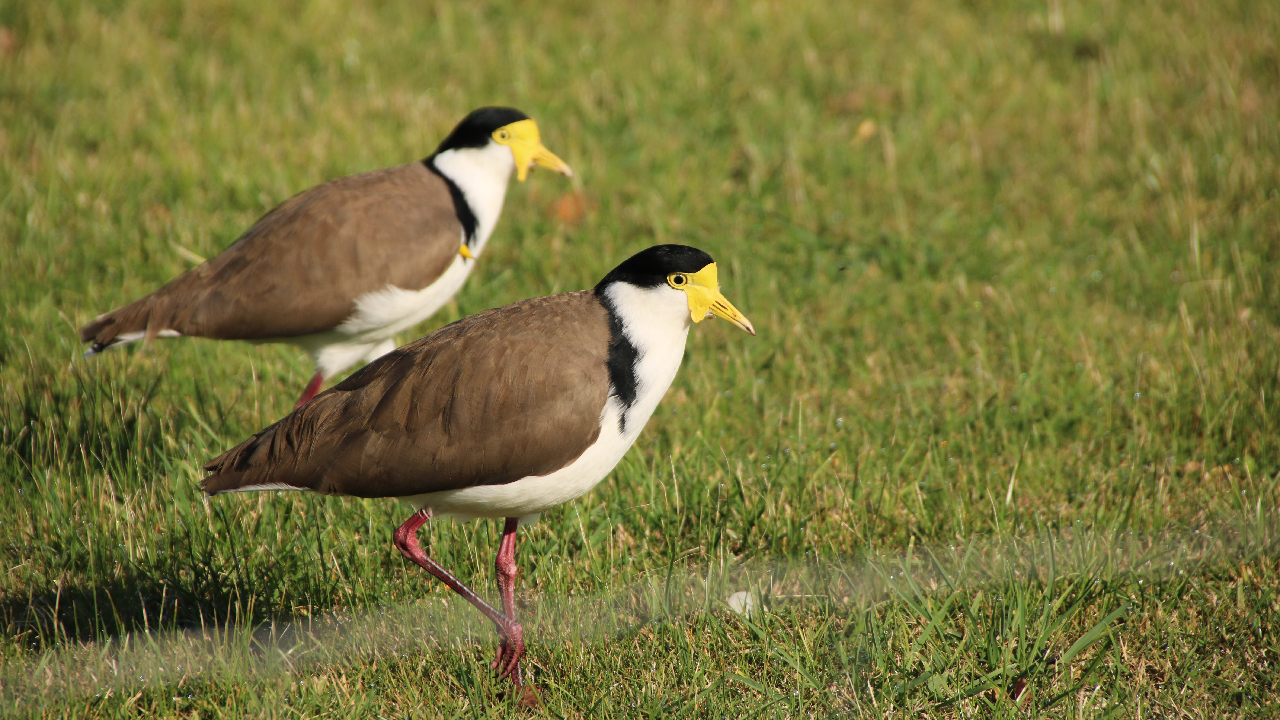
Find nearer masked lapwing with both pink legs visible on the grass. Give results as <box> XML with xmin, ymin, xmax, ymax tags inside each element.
<box><xmin>202</xmin><ymin>245</ymin><xmax>755</xmax><ymax>685</ymax></box>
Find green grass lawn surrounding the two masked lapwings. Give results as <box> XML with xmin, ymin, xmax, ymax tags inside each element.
<box><xmin>0</xmin><ymin>0</ymin><xmax>1280</xmax><ymax>717</ymax></box>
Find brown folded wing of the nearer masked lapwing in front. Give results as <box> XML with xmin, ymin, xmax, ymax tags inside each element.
<box><xmin>202</xmin><ymin>291</ymin><xmax>609</xmax><ymax>497</ymax></box>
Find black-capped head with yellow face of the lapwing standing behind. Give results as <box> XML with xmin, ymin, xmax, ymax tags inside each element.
<box><xmin>433</xmin><ymin>108</ymin><xmax>573</xmax><ymax>182</ymax></box>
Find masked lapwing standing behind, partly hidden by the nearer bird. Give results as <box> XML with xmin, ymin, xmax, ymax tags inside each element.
<box><xmin>81</xmin><ymin>108</ymin><xmax>573</xmax><ymax>406</ymax></box>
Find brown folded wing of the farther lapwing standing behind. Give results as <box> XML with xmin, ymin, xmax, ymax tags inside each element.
<box><xmin>81</xmin><ymin>163</ymin><xmax>462</xmax><ymax>347</ymax></box>
